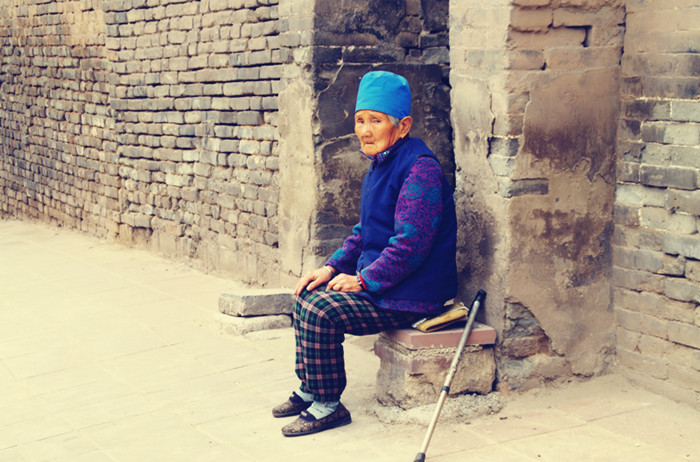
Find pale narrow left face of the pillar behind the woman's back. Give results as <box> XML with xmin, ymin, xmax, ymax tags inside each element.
<box><xmin>450</xmin><ymin>1</ymin><xmax>510</xmax><ymax>333</ymax></box>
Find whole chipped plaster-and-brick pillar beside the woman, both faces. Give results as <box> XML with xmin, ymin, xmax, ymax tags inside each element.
<box><xmin>451</xmin><ymin>0</ymin><xmax>624</xmax><ymax>389</ymax></box>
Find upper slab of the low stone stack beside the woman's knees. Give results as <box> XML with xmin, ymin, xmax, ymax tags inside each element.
<box><xmin>219</xmin><ymin>289</ymin><xmax>294</xmax><ymax>317</ymax></box>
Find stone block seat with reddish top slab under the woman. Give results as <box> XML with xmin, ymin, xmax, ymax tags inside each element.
<box><xmin>374</xmin><ymin>322</ymin><xmax>496</xmax><ymax>409</ymax></box>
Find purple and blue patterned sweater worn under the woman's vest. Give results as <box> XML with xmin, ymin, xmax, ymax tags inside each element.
<box><xmin>326</xmin><ymin>153</ymin><xmax>444</xmax><ymax>315</ymax></box>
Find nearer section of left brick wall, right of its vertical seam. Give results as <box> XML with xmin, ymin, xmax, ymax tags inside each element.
<box><xmin>104</xmin><ymin>0</ymin><xmax>286</xmax><ymax>280</ymax></box>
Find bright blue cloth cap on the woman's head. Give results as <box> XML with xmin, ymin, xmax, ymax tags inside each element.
<box><xmin>355</xmin><ymin>71</ymin><xmax>411</xmax><ymax>119</ymax></box>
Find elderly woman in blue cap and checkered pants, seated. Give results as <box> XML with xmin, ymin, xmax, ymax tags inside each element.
<box><xmin>272</xmin><ymin>71</ymin><xmax>457</xmax><ymax>436</ymax></box>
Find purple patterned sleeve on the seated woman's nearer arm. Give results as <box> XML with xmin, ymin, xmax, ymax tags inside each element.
<box><xmin>360</xmin><ymin>157</ymin><xmax>442</xmax><ymax>293</ymax></box>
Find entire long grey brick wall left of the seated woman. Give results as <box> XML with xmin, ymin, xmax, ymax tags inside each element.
<box><xmin>0</xmin><ymin>0</ymin><xmax>288</xmax><ymax>281</ymax></box>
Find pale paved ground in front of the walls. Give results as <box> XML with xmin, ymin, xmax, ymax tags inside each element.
<box><xmin>0</xmin><ymin>221</ymin><xmax>700</xmax><ymax>462</ymax></box>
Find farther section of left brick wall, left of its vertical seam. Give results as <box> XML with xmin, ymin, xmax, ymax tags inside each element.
<box><xmin>0</xmin><ymin>0</ymin><xmax>119</xmax><ymax>236</ymax></box>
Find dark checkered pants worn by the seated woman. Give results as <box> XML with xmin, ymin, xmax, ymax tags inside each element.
<box><xmin>294</xmin><ymin>290</ymin><xmax>422</xmax><ymax>402</ymax></box>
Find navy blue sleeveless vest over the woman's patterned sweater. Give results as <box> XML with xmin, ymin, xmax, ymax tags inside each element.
<box><xmin>357</xmin><ymin>138</ymin><xmax>457</xmax><ymax>303</ymax></box>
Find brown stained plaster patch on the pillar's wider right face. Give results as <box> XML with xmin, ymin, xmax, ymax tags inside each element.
<box><xmin>509</xmin><ymin>69</ymin><xmax>618</xmax><ymax>375</ymax></box>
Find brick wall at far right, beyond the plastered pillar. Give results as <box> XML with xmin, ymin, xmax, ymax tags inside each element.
<box><xmin>614</xmin><ymin>0</ymin><xmax>700</xmax><ymax>405</ymax></box>
